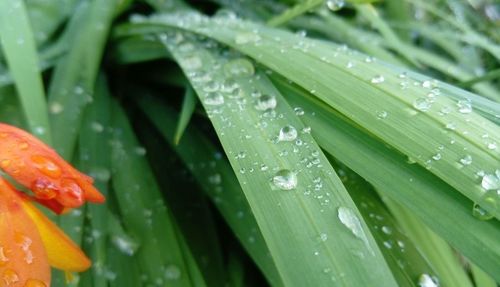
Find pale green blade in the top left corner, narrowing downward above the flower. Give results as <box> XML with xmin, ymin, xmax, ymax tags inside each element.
<box><xmin>0</xmin><ymin>0</ymin><xmax>52</xmax><ymax>144</ymax></box>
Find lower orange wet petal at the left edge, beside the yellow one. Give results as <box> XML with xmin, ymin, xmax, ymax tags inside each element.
<box><xmin>0</xmin><ymin>178</ymin><xmax>50</xmax><ymax>287</ymax></box>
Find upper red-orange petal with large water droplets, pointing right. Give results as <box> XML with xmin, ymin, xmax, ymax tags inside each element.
<box><xmin>0</xmin><ymin>123</ymin><xmax>104</xmax><ymax>213</ymax></box>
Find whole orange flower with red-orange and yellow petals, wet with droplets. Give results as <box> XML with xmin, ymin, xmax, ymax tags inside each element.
<box><xmin>0</xmin><ymin>124</ymin><xmax>104</xmax><ymax>287</ymax></box>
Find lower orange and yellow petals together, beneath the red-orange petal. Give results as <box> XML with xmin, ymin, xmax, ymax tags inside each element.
<box><xmin>0</xmin><ymin>178</ymin><xmax>91</xmax><ymax>287</ymax></box>
